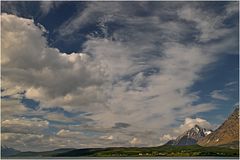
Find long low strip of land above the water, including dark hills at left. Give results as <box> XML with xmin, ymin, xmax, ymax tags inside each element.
<box><xmin>9</xmin><ymin>145</ymin><xmax>239</xmax><ymax>157</ymax></box>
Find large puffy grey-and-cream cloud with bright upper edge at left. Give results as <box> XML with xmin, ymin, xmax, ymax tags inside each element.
<box><xmin>1</xmin><ymin>14</ymin><xmax>108</xmax><ymax>112</ymax></box>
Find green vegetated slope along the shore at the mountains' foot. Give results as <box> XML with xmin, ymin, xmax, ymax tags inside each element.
<box><xmin>56</xmin><ymin>145</ymin><xmax>239</xmax><ymax>157</ymax></box>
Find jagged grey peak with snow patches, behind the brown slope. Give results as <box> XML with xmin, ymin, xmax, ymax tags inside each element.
<box><xmin>166</xmin><ymin>125</ymin><xmax>212</xmax><ymax>146</ymax></box>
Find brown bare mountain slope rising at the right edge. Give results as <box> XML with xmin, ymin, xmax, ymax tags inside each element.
<box><xmin>198</xmin><ymin>108</ymin><xmax>239</xmax><ymax>148</ymax></box>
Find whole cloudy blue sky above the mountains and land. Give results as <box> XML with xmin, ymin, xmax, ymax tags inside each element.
<box><xmin>1</xmin><ymin>1</ymin><xmax>239</xmax><ymax>151</ymax></box>
